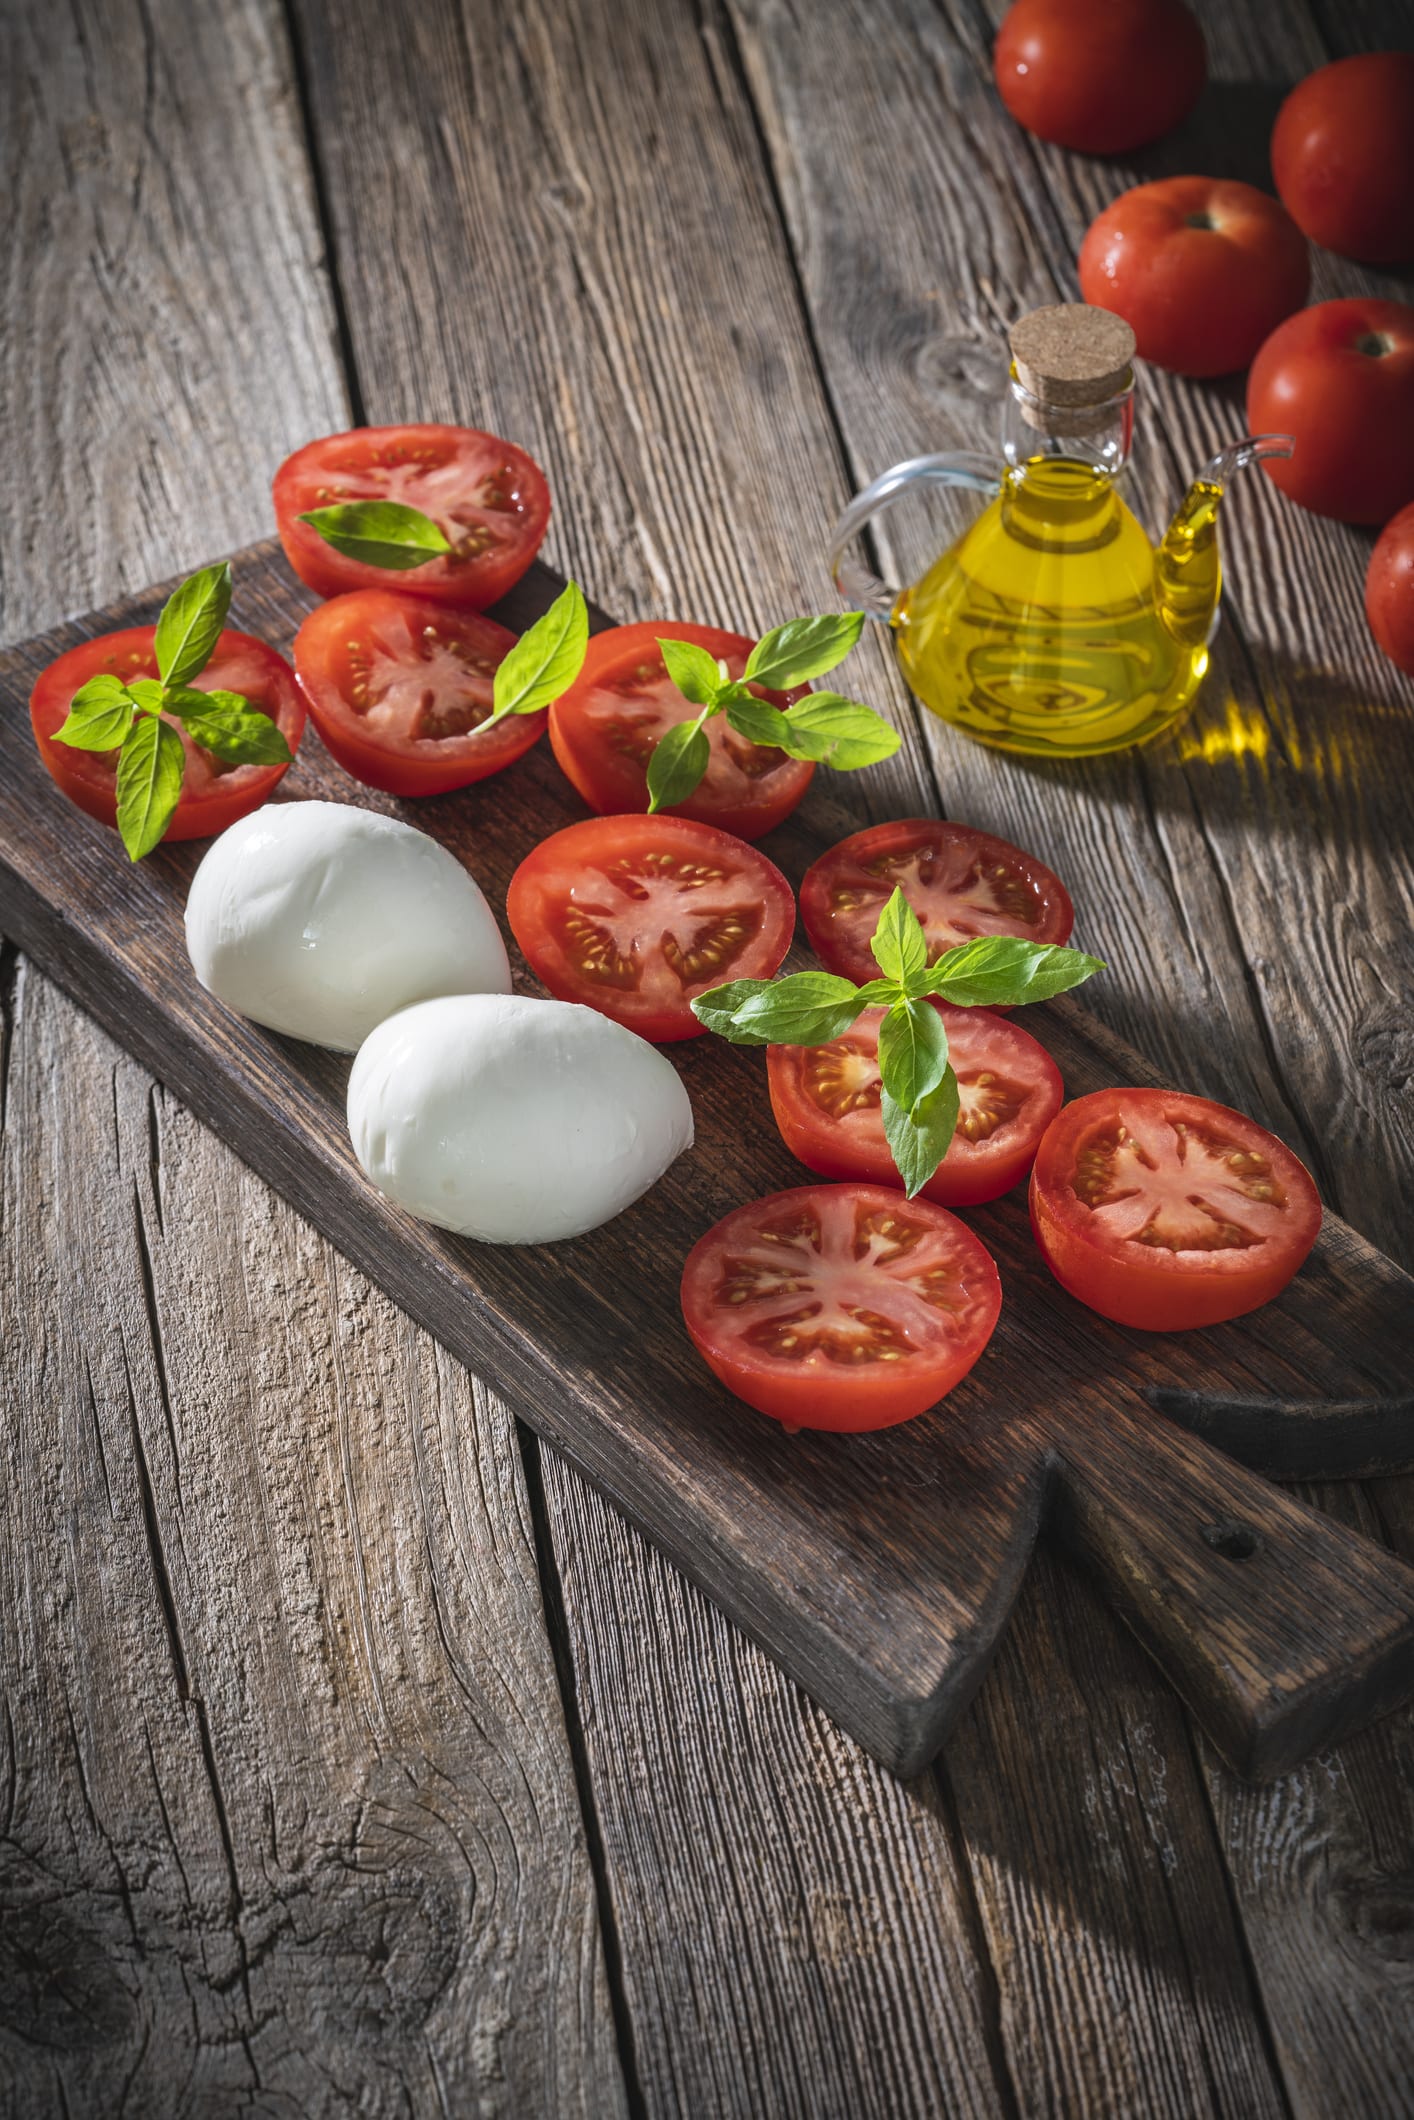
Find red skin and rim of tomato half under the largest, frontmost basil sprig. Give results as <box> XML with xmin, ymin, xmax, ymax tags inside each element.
<box><xmin>765</xmin><ymin>1003</ymin><xmax>1064</xmax><ymax>1206</ymax></box>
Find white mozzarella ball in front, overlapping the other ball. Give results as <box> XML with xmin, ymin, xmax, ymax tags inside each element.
<box><xmin>348</xmin><ymin>994</ymin><xmax>693</xmax><ymax>1244</ymax></box>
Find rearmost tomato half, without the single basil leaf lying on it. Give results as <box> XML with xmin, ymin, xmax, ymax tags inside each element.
<box><xmin>273</xmin><ymin>424</ymin><xmax>549</xmax><ymax>611</ymax></box>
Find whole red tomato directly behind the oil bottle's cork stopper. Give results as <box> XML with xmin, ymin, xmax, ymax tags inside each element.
<box><xmin>1079</xmin><ymin>176</ymin><xmax>1310</xmax><ymax>375</ymax></box>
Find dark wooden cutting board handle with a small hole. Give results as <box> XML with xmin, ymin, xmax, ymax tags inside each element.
<box><xmin>1056</xmin><ymin>1406</ymin><xmax>1414</xmax><ymax>1781</ymax></box>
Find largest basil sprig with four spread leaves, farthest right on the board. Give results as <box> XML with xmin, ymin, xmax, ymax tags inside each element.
<box><xmin>693</xmin><ymin>890</ymin><xmax>1104</xmax><ymax>1200</ymax></box>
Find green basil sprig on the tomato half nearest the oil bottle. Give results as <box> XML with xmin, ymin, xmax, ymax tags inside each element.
<box><xmin>649</xmin><ymin>611</ymin><xmax>899</xmax><ymax>810</ymax></box>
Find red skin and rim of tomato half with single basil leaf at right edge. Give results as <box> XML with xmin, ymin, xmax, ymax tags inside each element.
<box><xmin>295</xmin><ymin>587</ymin><xmax>549</xmax><ymax>795</ymax></box>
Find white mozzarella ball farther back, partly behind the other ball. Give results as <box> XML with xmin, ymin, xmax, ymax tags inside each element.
<box><xmin>187</xmin><ymin>801</ymin><xmax>511</xmax><ymax>1054</ymax></box>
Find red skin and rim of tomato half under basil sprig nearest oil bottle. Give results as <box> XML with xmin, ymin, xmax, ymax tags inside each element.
<box><xmin>549</xmin><ymin>619</ymin><xmax>814</xmax><ymax>840</ymax></box>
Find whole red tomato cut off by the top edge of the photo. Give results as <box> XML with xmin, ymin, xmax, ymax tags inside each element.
<box><xmin>992</xmin><ymin>0</ymin><xmax>1206</xmax><ymax>155</ymax></box>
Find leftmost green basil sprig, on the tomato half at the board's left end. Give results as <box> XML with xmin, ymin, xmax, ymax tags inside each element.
<box><xmin>55</xmin><ymin>564</ymin><xmax>295</xmax><ymax>861</ymax></box>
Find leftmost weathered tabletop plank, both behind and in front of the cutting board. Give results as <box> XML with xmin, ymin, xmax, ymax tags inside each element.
<box><xmin>0</xmin><ymin>0</ymin><xmax>623</xmax><ymax>2120</ymax></box>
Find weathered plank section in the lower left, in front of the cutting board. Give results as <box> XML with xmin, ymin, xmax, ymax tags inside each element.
<box><xmin>0</xmin><ymin>971</ymin><xmax>623</xmax><ymax>2120</ymax></box>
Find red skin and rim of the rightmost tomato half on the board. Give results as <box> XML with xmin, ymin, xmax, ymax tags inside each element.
<box><xmin>1028</xmin><ymin>1090</ymin><xmax>1321</xmax><ymax>1331</ymax></box>
